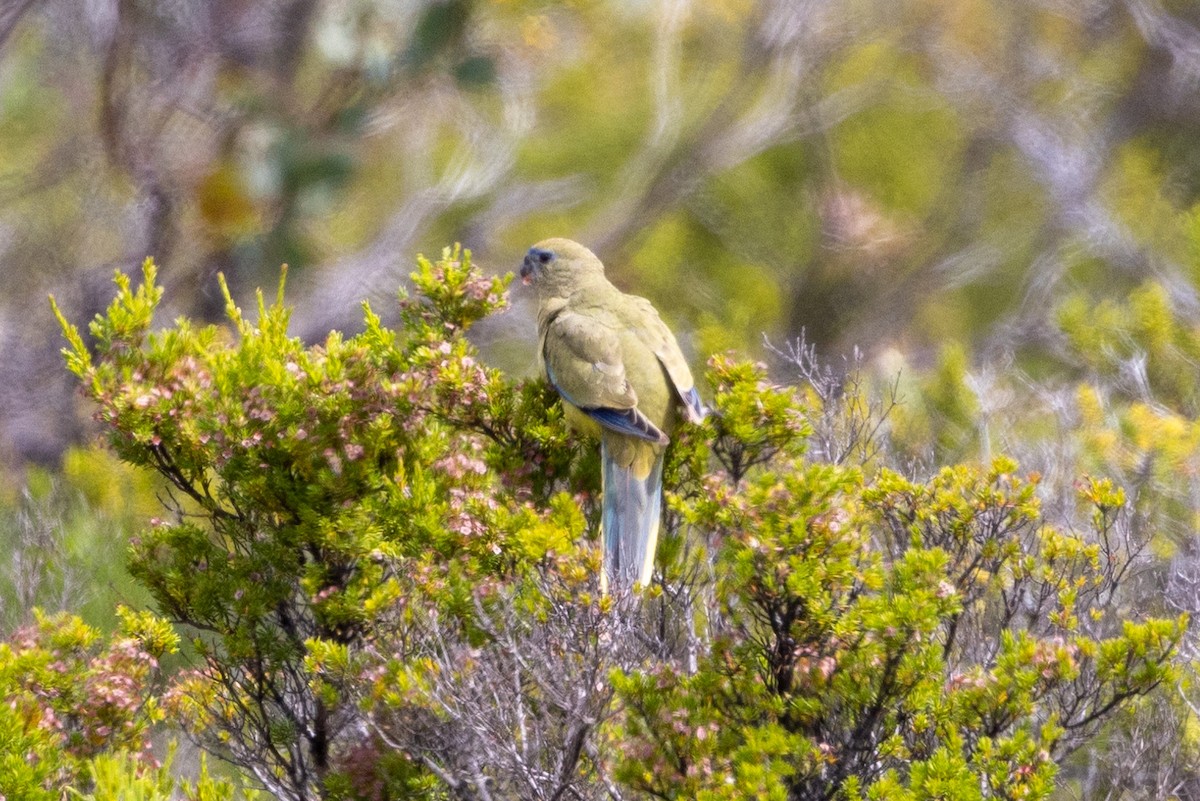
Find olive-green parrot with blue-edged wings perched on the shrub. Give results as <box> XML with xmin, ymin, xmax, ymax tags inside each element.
<box><xmin>521</xmin><ymin>239</ymin><xmax>704</xmax><ymax>588</ymax></box>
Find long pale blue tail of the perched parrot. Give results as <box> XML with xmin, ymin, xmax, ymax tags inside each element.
<box><xmin>600</xmin><ymin>441</ymin><xmax>664</xmax><ymax>589</ymax></box>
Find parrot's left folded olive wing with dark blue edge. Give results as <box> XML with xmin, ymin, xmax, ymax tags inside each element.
<box><xmin>542</xmin><ymin>308</ymin><xmax>667</xmax><ymax>444</ymax></box>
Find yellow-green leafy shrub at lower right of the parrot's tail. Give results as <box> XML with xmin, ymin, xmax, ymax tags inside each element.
<box><xmin>617</xmin><ymin>455</ymin><xmax>1186</xmax><ymax>800</ymax></box>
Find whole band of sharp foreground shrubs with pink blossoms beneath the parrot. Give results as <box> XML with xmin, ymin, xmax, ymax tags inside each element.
<box><xmin>0</xmin><ymin>249</ymin><xmax>1187</xmax><ymax>799</ymax></box>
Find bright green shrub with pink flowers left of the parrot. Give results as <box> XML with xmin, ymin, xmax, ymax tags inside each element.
<box><xmin>58</xmin><ymin>248</ymin><xmax>576</xmax><ymax>795</ymax></box>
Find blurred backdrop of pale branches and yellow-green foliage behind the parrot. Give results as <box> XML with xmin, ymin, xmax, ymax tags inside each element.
<box><xmin>0</xmin><ymin>0</ymin><xmax>1200</xmax><ymax>464</ymax></box>
